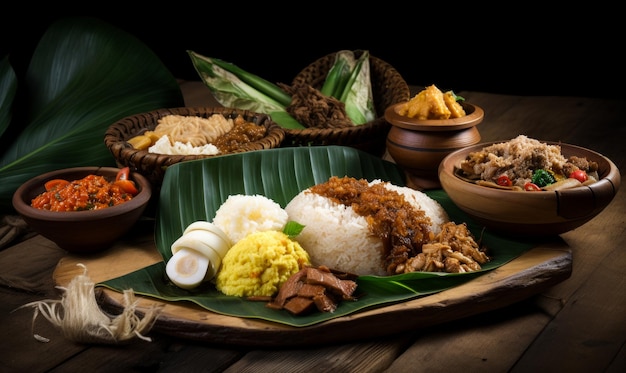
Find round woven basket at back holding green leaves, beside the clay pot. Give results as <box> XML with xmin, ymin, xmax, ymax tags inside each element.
<box><xmin>282</xmin><ymin>51</ymin><xmax>411</xmax><ymax>156</ymax></box>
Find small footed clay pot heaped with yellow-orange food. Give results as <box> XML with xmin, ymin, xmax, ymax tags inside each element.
<box><xmin>385</xmin><ymin>85</ymin><xmax>484</xmax><ymax>189</ymax></box>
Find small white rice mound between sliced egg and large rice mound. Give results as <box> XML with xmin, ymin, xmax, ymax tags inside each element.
<box><xmin>213</xmin><ymin>194</ymin><xmax>289</xmax><ymax>244</ymax></box>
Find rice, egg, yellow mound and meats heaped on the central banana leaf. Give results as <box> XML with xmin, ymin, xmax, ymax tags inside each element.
<box><xmin>167</xmin><ymin>177</ymin><xmax>490</xmax><ymax>314</ymax></box>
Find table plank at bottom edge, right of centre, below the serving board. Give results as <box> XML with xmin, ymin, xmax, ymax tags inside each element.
<box><xmin>386</xmin><ymin>299</ymin><xmax>550</xmax><ymax>373</ymax></box>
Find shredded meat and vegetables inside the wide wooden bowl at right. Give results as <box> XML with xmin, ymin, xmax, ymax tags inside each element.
<box><xmin>456</xmin><ymin>135</ymin><xmax>599</xmax><ymax>191</ymax></box>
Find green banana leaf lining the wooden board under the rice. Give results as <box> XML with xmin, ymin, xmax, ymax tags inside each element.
<box><xmin>97</xmin><ymin>146</ymin><xmax>534</xmax><ymax>327</ymax></box>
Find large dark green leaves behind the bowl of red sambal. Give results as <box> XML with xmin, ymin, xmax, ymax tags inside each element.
<box><xmin>0</xmin><ymin>17</ymin><xmax>186</xmax><ymax>212</ymax></box>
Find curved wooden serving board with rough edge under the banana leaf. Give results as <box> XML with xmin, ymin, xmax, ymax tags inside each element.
<box><xmin>53</xmin><ymin>237</ymin><xmax>572</xmax><ymax>347</ymax></box>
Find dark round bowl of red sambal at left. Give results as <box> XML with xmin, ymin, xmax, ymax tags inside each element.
<box><xmin>13</xmin><ymin>167</ymin><xmax>152</xmax><ymax>254</ymax></box>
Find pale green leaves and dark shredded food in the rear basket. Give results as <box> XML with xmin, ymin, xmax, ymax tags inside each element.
<box><xmin>188</xmin><ymin>50</ymin><xmax>376</xmax><ymax>129</ymax></box>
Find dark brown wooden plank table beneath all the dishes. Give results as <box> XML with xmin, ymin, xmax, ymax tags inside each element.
<box><xmin>0</xmin><ymin>82</ymin><xmax>626</xmax><ymax>372</ymax></box>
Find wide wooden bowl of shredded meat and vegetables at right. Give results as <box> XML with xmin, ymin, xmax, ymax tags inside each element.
<box><xmin>439</xmin><ymin>135</ymin><xmax>621</xmax><ymax>237</ymax></box>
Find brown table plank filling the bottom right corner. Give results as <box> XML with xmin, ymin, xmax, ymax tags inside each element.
<box><xmin>514</xmin><ymin>219</ymin><xmax>626</xmax><ymax>372</ymax></box>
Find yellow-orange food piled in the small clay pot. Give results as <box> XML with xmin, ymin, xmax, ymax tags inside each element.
<box><xmin>398</xmin><ymin>84</ymin><xmax>465</xmax><ymax>120</ymax></box>
